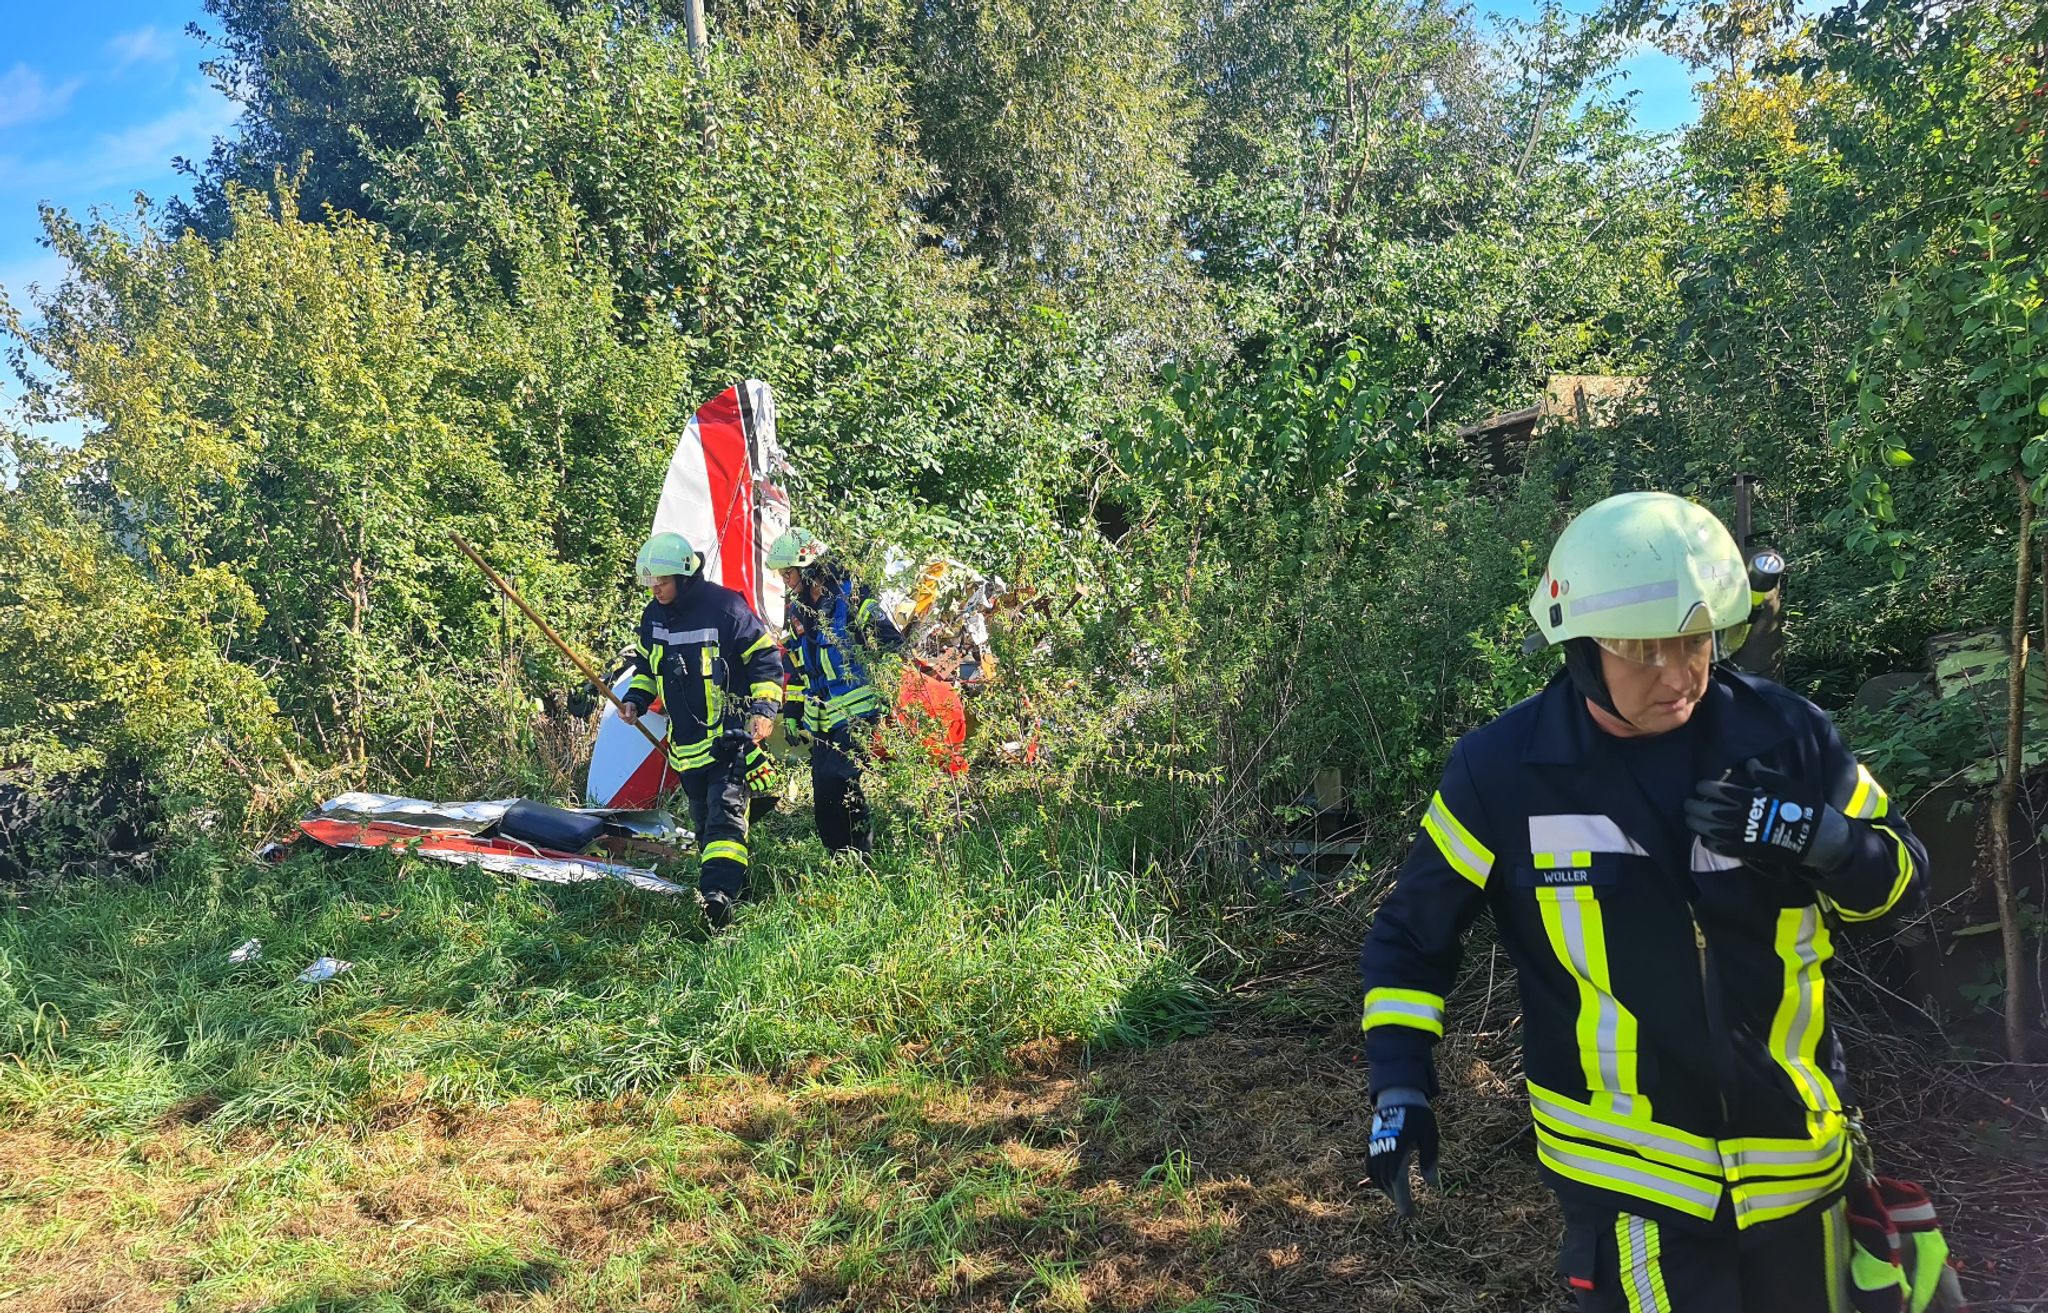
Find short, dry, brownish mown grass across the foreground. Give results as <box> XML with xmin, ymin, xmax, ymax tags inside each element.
<box><xmin>0</xmin><ymin>979</ymin><xmax>2048</xmax><ymax>1313</ymax></box>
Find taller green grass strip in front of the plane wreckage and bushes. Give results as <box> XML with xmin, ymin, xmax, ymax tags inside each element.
<box><xmin>0</xmin><ymin>802</ymin><xmax>1204</xmax><ymax>1131</ymax></box>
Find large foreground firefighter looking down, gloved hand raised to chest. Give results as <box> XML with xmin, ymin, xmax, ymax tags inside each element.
<box><xmin>1362</xmin><ymin>494</ymin><xmax>1925</xmax><ymax>1313</ymax></box>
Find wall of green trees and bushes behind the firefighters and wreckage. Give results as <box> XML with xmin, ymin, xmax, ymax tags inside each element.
<box><xmin>0</xmin><ymin>0</ymin><xmax>2048</xmax><ymax>1003</ymax></box>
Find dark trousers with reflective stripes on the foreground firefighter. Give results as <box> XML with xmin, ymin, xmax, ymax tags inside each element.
<box><xmin>1559</xmin><ymin>1198</ymin><xmax>1849</xmax><ymax>1313</ymax></box>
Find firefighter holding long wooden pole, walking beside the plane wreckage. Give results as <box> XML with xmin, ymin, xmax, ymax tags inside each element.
<box><xmin>623</xmin><ymin>533</ymin><xmax>782</xmax><ymax>930</ymax></box>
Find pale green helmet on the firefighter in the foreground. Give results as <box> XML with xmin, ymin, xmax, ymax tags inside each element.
<box><xmin>1530</xmin><ymin>492</ymin><xmax>1751</xmax><ymax>660</ymax></box>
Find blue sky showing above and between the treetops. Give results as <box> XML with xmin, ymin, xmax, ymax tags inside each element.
<box><xmin>0</xmin><ymin>0</ymin><xmax>1696</xmax><ymax>438</ymax></box>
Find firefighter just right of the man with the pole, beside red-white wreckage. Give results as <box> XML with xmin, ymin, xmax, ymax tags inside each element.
<box><xmin>768</xmin><ymin>528</ymin><xmax>903</xmax><ymax>852</ymax></box>
